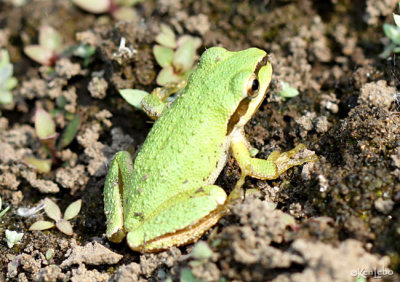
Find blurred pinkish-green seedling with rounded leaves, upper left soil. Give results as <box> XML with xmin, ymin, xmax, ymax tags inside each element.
<box><xmin>24</xmin><ymin>25</ymin><xmax>62</xmax><ymax>66</ymax></box>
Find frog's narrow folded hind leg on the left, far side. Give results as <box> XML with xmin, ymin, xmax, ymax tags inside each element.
<box><xmin>104</xmin><ymin>151</ymin><xmax>133</xmax><ymax>243</ymax></box>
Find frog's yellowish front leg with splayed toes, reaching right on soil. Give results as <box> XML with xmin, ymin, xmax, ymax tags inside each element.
<box><xmin>229</xmin><ymin>130</ymin><xmax>318</xmax><ymax>202</ymax></box>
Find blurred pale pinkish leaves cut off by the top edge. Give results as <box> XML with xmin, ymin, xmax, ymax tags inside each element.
<box><xmin>72</xmin><ymin>0</ymin><xmax>143</xmax><ymax>21</ymax></box>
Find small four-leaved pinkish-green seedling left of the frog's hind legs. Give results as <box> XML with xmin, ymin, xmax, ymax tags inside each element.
<box><xmin>29</xmin><ymin>198</ymin><xmax>82</xmax><ymax>236</ymax></box>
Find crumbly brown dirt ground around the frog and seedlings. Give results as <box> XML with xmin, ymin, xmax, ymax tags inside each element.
<box><xmin>0</xmin><ymin>0</ymin><xmax>400</xmax><ymax>282</ymax></box>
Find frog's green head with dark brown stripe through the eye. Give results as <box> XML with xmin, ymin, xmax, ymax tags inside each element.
<box><xmin>193</xmin><ymin>47</ymin><xmax>272</xmax><ymax>133</ymax></box>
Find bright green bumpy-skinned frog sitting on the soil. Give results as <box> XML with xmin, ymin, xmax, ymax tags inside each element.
<box><xmin>104</xmin><ymin>47</ymin><xmax>315</xmax><ymax>252</ymax></box>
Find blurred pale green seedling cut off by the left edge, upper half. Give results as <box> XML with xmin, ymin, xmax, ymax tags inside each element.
<box><xmin>0</xmin><ymin>49</ymin><xmax>18</xmax><ymax>105</ymax></box>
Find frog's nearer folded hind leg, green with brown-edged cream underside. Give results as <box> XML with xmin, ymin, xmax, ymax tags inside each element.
<box><xmin>127</xmin><ymin>185</ymin><xmax>227</xmax><ymax>252</ymax></box>
